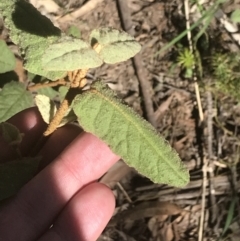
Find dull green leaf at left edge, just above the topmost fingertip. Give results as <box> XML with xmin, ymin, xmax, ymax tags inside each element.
<box><xmin>0</xmin><ymin>81</ymin><xmax>33</xmax><ymax>122</ymax></box>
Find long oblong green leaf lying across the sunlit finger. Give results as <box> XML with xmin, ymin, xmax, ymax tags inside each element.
<box><xmin>73</xmin><ymin>82</ymin><xmax>189</xmax><ymax>187</ymax></box>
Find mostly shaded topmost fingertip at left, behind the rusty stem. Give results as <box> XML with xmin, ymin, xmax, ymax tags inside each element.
<box><xmin>0</xmin><ymin>107</ymin><xmax>46</xmax><ymax>162</ymax></box>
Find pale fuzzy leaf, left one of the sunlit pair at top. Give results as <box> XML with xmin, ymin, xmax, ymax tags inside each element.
<box><xmin>42</xmin><ymin>36</ymin><xmax>103</xmax><ymax>71</ymax></box>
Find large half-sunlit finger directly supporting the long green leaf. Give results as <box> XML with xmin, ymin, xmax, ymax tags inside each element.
<box><xmin>0</xmin><ymin>133</ymin><xmax>119</xmax><ymax>241</ymax></box>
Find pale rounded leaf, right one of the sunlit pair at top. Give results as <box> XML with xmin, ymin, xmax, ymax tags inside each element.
<box><xmin>90</xmin><ymin>28</ymin><xmax>141</xmax><ymax>64</ymax></box>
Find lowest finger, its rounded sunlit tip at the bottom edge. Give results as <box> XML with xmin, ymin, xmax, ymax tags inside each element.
<box><xmin>39</xmin><ymin>183</ymin><xmax>115</xmax><ymax>241</ymax></box>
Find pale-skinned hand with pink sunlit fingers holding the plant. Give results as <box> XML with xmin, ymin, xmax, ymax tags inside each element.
<box><xmin>0</xmin><ymin>108</ymin><xmax>119</xmax><ymax>241</ymax></box>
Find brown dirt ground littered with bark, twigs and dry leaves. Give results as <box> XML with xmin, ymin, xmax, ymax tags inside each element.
<box><xmin>5</xmin><ymin>0</ymin><xmax>240</xmax><ymax>241</ymax></box>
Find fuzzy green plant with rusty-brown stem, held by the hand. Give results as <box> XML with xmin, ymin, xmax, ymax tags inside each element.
<box><xmin>0</xmin><ymin>0</ymin><xmax>189</xmax><ymax>200</ymax></box>
